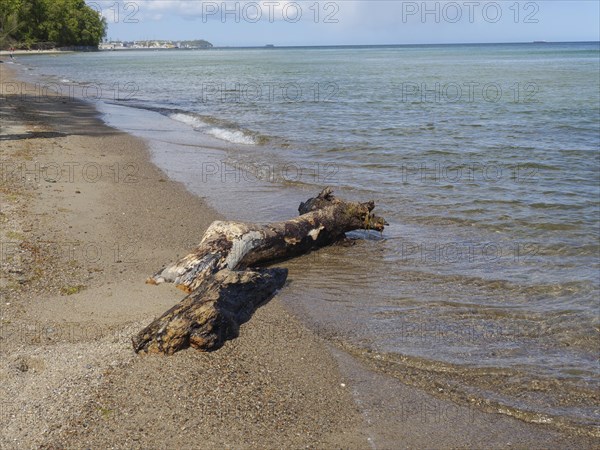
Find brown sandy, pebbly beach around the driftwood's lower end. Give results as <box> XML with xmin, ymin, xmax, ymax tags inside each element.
<box><xmin>0</xmin><ymin>64</ymin><xmax>597</xmax><ymax>449</ymax></box>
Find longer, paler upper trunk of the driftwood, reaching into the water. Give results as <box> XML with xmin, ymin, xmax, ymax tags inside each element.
<box><xmin>147</xmin><ymin>188</ymin><xmax>387</xmax><ymax>292</ymax></box>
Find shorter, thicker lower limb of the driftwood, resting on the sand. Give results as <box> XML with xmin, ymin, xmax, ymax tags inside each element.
<box><xmin>133</xmin><ymin>269</ymin><xmax>287</xmax><ymax>355</ymax></box>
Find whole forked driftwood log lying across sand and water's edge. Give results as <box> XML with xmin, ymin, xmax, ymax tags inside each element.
<box><xmin>133</xmin><ymin>188</ymin><xmax>387</xmax><ymax>354</ymax></box>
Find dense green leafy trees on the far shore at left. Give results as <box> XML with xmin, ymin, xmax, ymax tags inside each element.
<box><xmin>0</xmin><ymin>0</ymin><xmax>107</xmax><ymax>48</ymax></box>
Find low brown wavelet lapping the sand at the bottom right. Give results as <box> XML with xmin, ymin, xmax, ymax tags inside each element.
<box><xmin>338</xmin><ymin>342</ymin><xmax>599</xmax><ymax>437</ymax></box>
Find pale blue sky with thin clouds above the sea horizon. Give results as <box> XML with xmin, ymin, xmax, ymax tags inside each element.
<box><xmin>86</xmin><ymin>0</ymin><xmax>600</xmax><ymax>47</ymax></box>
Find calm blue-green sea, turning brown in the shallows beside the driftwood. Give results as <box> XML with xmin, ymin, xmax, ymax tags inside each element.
<box><xmin>15</xmin><ymin>43</ymin><xmax>600</xmax><ymax>433</ymax></box>
